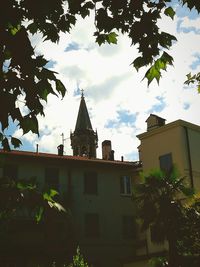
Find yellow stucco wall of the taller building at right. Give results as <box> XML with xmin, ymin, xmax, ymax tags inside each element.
<box><xmin>138</xmin><ymin>121</ymin><xmax>200</xmax><ymax>258</ymax></box>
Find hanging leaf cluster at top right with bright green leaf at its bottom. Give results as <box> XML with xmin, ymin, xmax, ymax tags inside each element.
<box><xmin>94</xmin><ymin>0</ymin><xmax>176</xmax><ymax>84</ymax></box>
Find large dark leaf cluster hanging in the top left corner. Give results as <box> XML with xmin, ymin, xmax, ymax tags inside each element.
<box><xmin>0</xmin><ymin>0</ymin><xmax>68</xmax><ymax>150</ymax></box>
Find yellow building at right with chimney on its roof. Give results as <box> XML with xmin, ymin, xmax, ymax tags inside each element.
<box><xmin>137</xmin><ymin>114</ymin><xmax>200</xmax><ymax>191</ymax></box>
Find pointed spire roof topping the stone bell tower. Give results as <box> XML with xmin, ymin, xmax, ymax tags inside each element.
<box><xmin>75</xmin><ymin>90</ymin><xmax>92</xmax><ymax>131</ymax></box>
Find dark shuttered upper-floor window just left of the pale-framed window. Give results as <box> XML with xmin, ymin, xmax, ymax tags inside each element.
<box><xmin>84</xmin><ymin>172</ymin><xmax>98</xmax><ymax>195</ymax></box>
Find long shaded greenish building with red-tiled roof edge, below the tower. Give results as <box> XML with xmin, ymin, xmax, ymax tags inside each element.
<box><xmin>1</xmin><ymin>151</ymin><xmax>141</xmax><ymax>267</ymax></box>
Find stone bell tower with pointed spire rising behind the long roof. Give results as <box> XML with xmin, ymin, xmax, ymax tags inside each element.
<box><xmin>70</xmin><ymin>90</ymin><xmax>98</xmax><ymax>158</ymax></box>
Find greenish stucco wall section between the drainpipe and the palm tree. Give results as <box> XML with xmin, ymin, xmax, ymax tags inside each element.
<box><xmin>71</xmin><ymin>165</ymin><xmax>138</xmax><ymax>266</ymax></box>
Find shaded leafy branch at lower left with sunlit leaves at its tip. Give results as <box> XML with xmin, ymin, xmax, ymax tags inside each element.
<box><xmin>0</xmin><ymin>178</ymin><xmax>66</xmax><ymax>223</ymax></box>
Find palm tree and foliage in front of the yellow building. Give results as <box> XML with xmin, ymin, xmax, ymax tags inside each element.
<box><xmin>134</xmin><ymin>172</ymin><xmax>200</xmax><ymax>266</ymax></box>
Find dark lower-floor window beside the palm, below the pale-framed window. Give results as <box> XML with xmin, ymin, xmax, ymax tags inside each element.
<box><xmin>122</xmin><ymin>215</ymin><xmax>137</xmax><ymax>239</ymax></box>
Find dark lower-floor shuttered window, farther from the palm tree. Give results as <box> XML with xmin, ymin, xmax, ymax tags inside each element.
<box><xmin>85</xmin><ymin>213</ymin><xmax>100</xmax><ymax>238</ymax></box>
